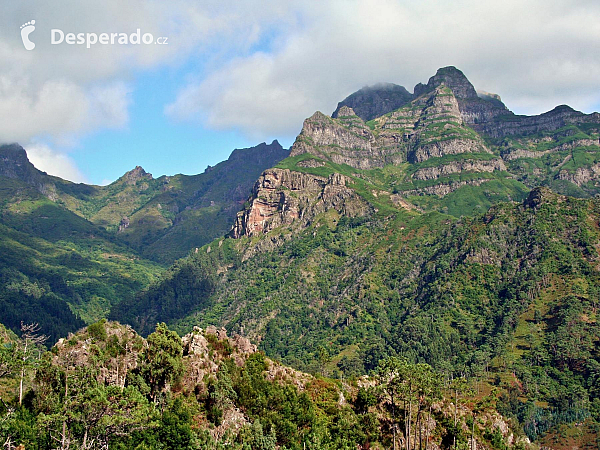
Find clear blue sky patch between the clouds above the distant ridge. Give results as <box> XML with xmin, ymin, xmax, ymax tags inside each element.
<box><xmin>72</xmin><ymin>69</ymin><xmax>284</xmax><ymax>184</ymax></box>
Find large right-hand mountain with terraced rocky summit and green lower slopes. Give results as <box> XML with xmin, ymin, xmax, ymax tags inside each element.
<box><xmin>110</xmin><ymin>67</ymin><xmax>600</xmax><ymax>439</ymax></box>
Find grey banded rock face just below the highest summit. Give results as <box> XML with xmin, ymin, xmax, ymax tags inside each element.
<box><xmin>291</xmin><ymin>85</ymin><xmax>489</xmax><ymax>170</ymax></box>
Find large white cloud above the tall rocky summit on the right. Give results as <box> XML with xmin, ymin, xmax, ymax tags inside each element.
<box><xmin>165</xmin><ymin>0</ymin><xmax>600</xmax><ymax>137</ymax></box>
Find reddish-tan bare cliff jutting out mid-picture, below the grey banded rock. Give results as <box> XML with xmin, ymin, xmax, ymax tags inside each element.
<box><xmin>230</xmin><ymin>169</ymin><xmax>370</xmax><ymax>238</ymax></box>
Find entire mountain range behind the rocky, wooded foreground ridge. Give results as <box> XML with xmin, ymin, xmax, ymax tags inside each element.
<box><xmin>0</xmin><ymin>67</ymin><xmax>600</xmax><ymax>446</ymax></box>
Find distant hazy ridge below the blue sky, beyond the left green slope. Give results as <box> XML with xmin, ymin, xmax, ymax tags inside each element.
<box><xmin>0</xmin><ymin>141</ymin><xmax>288</xmax><ymax>264</ymax></box>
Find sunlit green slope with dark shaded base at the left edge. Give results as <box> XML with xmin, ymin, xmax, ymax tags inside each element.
<box><xmin>0</xmin><ymin>178</ymin><xmax>162</xmax><ymax>339</ymax></box>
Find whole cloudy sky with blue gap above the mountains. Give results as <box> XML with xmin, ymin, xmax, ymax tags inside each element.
<box><xmin>0</xmin><ymin>0</ymin><xmax>600</xmax><ymax>184</ymax></box>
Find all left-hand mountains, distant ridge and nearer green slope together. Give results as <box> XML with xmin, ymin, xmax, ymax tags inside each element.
<box><xmin>0</xmin><ymin>141</ymin><xmax>288</xmax><ymax>342</ymax></box>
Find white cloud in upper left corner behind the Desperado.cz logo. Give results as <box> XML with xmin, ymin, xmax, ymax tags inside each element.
<box><xmin>0</xmin><ymin>0</ymin><xmax>288</xmax><ymax>142</ymax></box>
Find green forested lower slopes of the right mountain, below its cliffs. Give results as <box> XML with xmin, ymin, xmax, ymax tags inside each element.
<box><xmin>113</xmin><ymin>189</ymin><xmax>600</xmax><ymax>444</ymax></box>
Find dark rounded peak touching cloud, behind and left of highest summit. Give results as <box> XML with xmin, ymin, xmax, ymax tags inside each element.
<box><xmin>331</xmin><ymin>83</ymin><xmax>414</xmax><ymax>122</ymax></box>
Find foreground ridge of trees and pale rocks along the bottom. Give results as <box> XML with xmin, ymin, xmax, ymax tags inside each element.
<box><xmin>0</xmin><ymin>320</ymin><xmax>548</xmax><ymax>450</ymax></box>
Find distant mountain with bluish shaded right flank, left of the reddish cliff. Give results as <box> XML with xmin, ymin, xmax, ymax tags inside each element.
<box><xmin>77</xmin><ymin>141</ymin><xmax>288</xmax><ymax>264</ymax></box>
